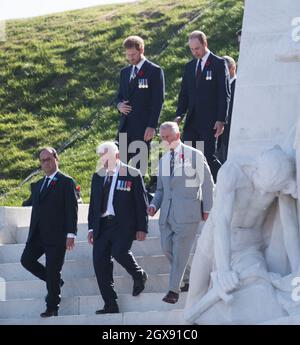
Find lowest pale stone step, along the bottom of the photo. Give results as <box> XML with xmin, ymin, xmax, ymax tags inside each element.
<box><xmin>0</xmin><ymin>309</ymin><xmax>187</xmax><ymax>324</ymax></box>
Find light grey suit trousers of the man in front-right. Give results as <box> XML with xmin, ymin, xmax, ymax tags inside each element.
<box><xmin>159</xmin><ymin>210</ymin><xmax>199</xmax><ymax>293</ymax></box>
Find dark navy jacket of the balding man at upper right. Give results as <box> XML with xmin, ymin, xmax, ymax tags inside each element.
<box><xmin>176</xmin><ymin>53</ymin><xmax>230</xmax><ymax>130</ymax></box>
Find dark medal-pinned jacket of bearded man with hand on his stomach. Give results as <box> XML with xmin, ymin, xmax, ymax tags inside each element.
<box><xmin>116</xmin><ymin>60</ymin><xmax>165</xmax><ymax>140</ymax></box>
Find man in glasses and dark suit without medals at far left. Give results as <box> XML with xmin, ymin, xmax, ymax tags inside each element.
<box><xmin>21</xmin><ymin>147</ymin><xmax>78</xmax><ymax>317</ymax></box>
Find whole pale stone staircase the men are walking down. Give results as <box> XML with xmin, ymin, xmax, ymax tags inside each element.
<box><xmin>0</xmin><ymin>205</ymin><xmax>195</xmax><ymax>325</ymax></box>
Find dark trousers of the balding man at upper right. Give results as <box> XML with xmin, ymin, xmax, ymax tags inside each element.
<box><xmin>183</xmin><ymin>126</ymin><xmax>221</xmax><ymax>182</ymax></box>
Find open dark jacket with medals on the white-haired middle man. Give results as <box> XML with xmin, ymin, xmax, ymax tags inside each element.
<box><xmin>88</xmin><ymin>163</ymin><xmax>148</xmax><ymax>241</ymax></box>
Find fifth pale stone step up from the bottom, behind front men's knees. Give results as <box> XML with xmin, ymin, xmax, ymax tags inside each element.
<box><xmin>0</xmin><ymin>237</ymin><xmax>166</xmax><ymax>263</ymax></box>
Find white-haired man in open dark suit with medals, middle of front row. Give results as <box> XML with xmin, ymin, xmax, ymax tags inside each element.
<box><xmin>88</xmin><ymin>142</ymin><xmax>148</xmax><ymax>314</ymax></box>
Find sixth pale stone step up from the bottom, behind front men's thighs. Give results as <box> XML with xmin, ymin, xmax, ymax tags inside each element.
<box><xmin>16</xmin><ymin>219</ymin><xmax>159</xmax><ymax>243</ymax></box>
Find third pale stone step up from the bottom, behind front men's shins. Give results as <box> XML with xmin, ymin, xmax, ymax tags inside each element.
<box><xmin>2</xmin><ymin>273</ymin><xmax>169</xmax><ymax>300</ymax></box>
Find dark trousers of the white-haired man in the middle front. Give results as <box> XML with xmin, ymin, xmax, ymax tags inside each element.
<box><xmin>93</xmin><ymin>218</ymin><xmax>143</xmax><ymax>306</ymax></box>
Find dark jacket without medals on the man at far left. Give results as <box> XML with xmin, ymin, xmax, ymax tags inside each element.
<box><xmin>27</xmin><ymin>171</ymin><xmax>78</xmax><ymax>245</ymax></box>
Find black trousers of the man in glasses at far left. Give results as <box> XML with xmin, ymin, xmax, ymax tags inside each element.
<box><xmin>21</xmin><ymin>235</ymin><xmax>66</xmax><ymax>311</ymax></box>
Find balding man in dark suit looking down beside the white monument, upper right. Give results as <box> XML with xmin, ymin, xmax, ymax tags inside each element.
<box><xmin>175</xmin><ymin>31</ymin><xmax>230</xmax><ymax>181</ymax></box>
